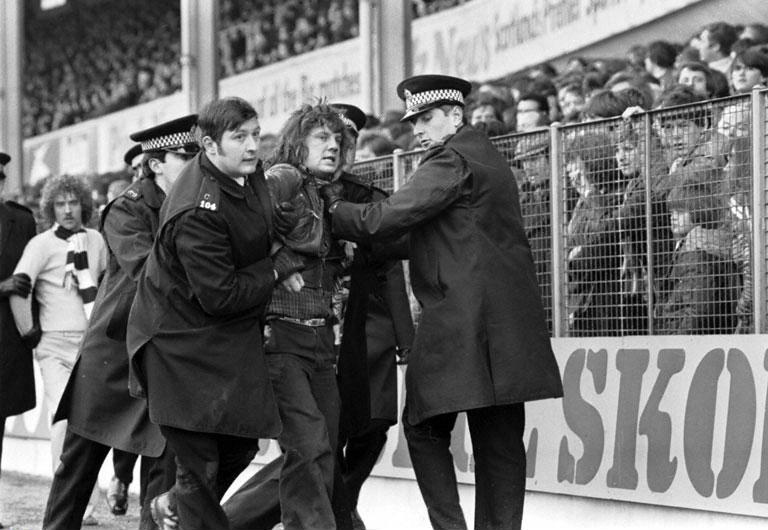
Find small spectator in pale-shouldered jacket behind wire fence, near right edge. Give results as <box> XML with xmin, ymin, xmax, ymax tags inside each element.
<box><xmin>654</xmin><ymin>171</ymin><xmax>741</xmax><ymax>335</ymax></box>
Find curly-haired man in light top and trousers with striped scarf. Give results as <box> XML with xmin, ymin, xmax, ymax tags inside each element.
<box><xmin>11</xmin><ymin>175</ymin><xmax>107</xmax><ymax>517</ymax></box>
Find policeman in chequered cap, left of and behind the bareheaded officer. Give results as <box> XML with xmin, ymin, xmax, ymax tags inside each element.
<box><xmin>43</xmin><ymin>114</ymin><xmax>199</xmax><ymax>529</ymax></box>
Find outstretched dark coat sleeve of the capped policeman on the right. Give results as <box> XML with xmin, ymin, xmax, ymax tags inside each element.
<box><xmin>333</xmin><ymin>146</ymin><xmax>471</xmax><ymax>241</ymax></box>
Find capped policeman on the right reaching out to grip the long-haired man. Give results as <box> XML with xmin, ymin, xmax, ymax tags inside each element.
<box><xmin>323</xmin><ymin>75</ymin><xmax>562</xmax><ymax>529</ymax></box>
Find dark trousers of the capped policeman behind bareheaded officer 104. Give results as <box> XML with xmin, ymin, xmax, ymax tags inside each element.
<box><xmin>43</xmin><ymin>429</ymin><xmax>173</xmax><ymax>530</ymax></box>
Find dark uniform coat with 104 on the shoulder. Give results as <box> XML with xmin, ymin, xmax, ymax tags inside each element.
<box><xmin>128</xmin><ymin>153</ymin><xmax>281</xmax><ymax>438</ymax></box>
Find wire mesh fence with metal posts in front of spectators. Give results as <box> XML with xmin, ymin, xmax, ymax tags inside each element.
<box><xmin>355</xmin><ymin>86</ymin><xmax>768</xmax><ymax>337</ymax></box>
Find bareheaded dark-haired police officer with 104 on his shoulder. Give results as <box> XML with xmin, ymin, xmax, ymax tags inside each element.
<box><xmin>128</xmin><ymin>98</ymin><xmax>287</xmax><ymax>530</ymax></box>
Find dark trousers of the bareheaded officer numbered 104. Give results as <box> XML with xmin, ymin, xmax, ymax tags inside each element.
<box><xmin>160</xmin><ymin>425</ymin><xmax>259</xmax><ymax>530</ymax></box>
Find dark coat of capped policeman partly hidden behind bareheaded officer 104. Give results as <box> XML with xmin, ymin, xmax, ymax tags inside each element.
<box><xmin>54</xmin><ymin>178</ymin><xmax>165</xmax><ymax>456</ymax></box>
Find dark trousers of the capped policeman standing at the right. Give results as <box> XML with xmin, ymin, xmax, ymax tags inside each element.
<box><xmin>403</xmin><ymin>403</ymin><xmax>526</xmax><ymax>530</ymax></box>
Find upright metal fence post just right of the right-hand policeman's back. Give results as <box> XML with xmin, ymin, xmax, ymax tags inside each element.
<box><xmin>549</xmin><ymin>125</ymin><xmax>565</xmax><ymax>337</ymax></box>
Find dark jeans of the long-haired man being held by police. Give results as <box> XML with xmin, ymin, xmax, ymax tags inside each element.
<box><xmin>265</xmin><ymin>321</ymin><xmax>340</xmax><ymax>530</ymax></box>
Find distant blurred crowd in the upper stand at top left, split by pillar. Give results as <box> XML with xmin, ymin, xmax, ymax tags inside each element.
<box><xmin>22</xmin><ymin>0</ymin><xmax>358</xmax><ymax>137</ymax></box>
